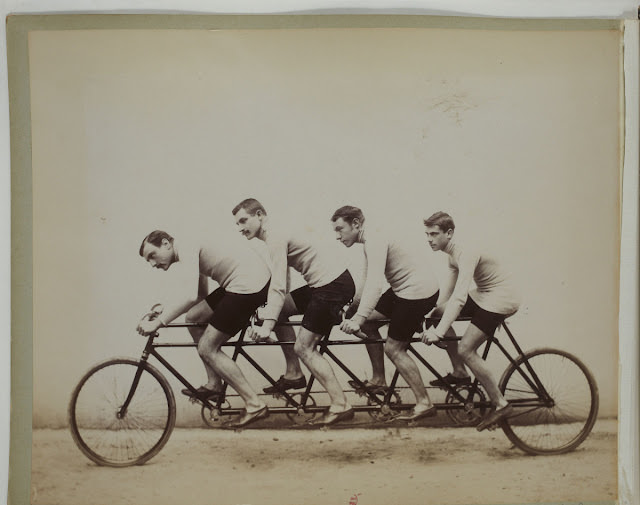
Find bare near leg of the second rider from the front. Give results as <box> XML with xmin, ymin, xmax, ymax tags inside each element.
<box><xmin>294</xmin><ymin>327</ymin><xmax>351</xmax><ymax>413</ymax></box>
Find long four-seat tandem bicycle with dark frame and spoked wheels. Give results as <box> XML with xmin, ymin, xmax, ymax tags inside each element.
<box><xmin>69</xmin><ymin>312</ymin><xmax>598</xmax><ymax>467</ymax></box>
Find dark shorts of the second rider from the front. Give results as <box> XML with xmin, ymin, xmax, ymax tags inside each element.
<box><xmin>296</xmin><ymin>270</ymin><xmax>356</xmax><ymax>335</ymax></box>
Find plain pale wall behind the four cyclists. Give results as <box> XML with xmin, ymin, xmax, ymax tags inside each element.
<box><xmin>30</xmin><ymin>25</ymin><xmax>620</xmax><ymax>427</ymax></box>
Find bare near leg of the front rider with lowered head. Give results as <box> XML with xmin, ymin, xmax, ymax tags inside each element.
<box><xmin>198</xmin><ymin>325</ymin><xmax>265</xmax><ymax>412</ymax></box>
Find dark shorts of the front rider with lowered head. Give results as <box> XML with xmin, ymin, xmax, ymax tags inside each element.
<box><xmin>205</xmin><ymin>282</ymin><xmax>269</xmax><ymax>337</ymax></box>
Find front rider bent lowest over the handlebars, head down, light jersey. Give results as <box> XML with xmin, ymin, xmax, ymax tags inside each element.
<box><xmin>137</xmin><ymin>230</ymin><xmax>270</xmax><ymax>427</ymax></box>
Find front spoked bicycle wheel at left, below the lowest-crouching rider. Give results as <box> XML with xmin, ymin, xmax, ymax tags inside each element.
<box><xmin>69</xmin><ymin>358</ymin><xmax>176</xmax><ymax>467</ymax></box>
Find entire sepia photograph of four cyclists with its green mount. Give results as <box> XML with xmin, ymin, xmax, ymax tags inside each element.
<box><xmin>7</xmin><ymin>10</ymin><xmax>637</xmax><ymax>505</ymax></box>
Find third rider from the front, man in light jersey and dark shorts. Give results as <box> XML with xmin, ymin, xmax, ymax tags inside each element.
<box><xmin>331</xmin><ymin>206</ymin><xmax>438</xmax><ymax>421</ymax></box>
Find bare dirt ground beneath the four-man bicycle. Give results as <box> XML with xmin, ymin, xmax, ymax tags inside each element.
<box><xmin>31</xmin><ymin>420</ymin><xmax>617</xmax><ymax>505</ymax></box>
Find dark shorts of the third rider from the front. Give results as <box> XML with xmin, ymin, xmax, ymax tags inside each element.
<box><xmin>376</xmin><ymin>288</ymin><xmax>438</xmax><ymax>342</ymax></box>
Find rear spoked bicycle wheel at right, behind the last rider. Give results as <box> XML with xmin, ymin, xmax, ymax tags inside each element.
<box><xmin>500</xmin><ymin>348</ymin><xmax>598</xmax><ymax>455</ymax></box>
